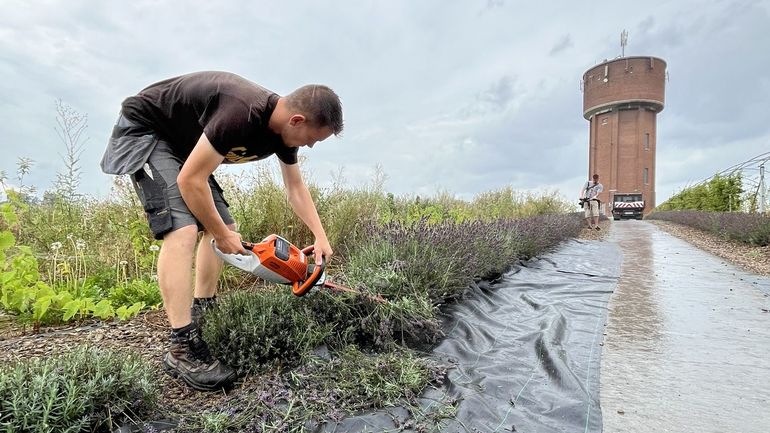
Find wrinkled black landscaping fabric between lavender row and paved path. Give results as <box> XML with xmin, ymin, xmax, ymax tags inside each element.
<box><xmin>317</xmin><ymin>241</ymin><xmax>622</xmax><ymax>433</ymax></box>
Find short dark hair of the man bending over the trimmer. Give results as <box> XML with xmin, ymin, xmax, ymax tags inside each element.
<box><xmin>286</xmin><ymin>84</ymin><xmax>343</xmax><ymax>135</ymax></box>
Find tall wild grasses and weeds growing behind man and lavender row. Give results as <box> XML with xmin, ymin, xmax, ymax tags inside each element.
<box><xmin>0</xmin><ymin>159</ymin><xmax>569</xmax><ymax>327</ymax></box>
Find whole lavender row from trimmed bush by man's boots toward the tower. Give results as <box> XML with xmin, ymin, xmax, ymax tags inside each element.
<box><xmin>204</xmin><ymin>215</ymin><xmax>581</xmax><ymax>373</ymax></box>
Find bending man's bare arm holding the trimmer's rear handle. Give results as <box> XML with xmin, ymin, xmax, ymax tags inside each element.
<box><xmin>177</xmin><ymin>134</ymin><xmax>245</xmax><ymax>254</ymax></box>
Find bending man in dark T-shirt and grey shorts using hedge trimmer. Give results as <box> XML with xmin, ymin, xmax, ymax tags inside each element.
<box><xmin>101</xmin><ymin>71</ymin><xmax>343</xmax><ymax>391</ymax></box>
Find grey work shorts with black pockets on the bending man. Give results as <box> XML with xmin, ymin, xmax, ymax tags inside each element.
<box><xmin>105</xmin><ymin>116</ymin><xmax>235</xmax><ymax>240</ymax></box>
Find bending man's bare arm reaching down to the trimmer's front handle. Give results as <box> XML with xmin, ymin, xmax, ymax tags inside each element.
<box><xmin>281</xmin><ymin>161</ymin><xmax>334</xmax><ymax>259</ymax></box>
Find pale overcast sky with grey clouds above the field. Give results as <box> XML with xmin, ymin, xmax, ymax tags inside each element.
<box><xmin>0</xmin><ymin>0</ymin><xmax>770</xmax><ymax>204</ymax></box>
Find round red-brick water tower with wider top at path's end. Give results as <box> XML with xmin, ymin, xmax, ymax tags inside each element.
<box><xmin>582</xmin><ymin>56</ymin><xmax>666</xmax><ymax>215</ymax></box>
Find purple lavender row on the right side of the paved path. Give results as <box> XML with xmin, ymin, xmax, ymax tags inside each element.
<box><xmin>647</xmin><ymin>210</ymin><xmax>770</xmax><ymax>246</ymax></box>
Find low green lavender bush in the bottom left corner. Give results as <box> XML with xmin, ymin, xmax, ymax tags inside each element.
<box><xmin>0</xmin><ymin>347</ymin><xmax>158</xmax><ymax>433</ymax></box>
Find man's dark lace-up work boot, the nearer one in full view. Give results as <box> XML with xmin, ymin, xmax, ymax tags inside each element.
<box><xmin>163</xmin><ymin>324</ymin><xmax>236</xmax><ymax>391</ymax></box>
